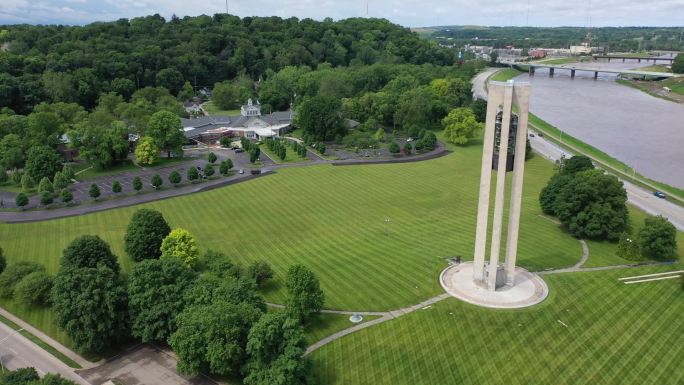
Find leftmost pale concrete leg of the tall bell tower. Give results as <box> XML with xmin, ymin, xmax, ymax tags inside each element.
<box><xmin>473</xmin><ymin>86</ymin><xmax>503</xmax><ymax>282</ymax></box>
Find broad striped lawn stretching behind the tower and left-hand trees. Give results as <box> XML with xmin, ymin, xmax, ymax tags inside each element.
<box><xmin>0</xmin><ymin>136</ymin><xmax>684</xmax><ymax>345</ymax></box>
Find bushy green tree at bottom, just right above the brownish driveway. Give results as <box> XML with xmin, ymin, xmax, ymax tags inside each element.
<box><xmin>169</xmin><ymin>301</ymin><xmax>262</xmax><ymax>376</ymax></box>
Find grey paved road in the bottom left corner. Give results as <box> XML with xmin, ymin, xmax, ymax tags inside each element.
<box><xmin>0</xmin><ymin>323</ymin><xmax>90</xmax><ymax>385</ymax></box>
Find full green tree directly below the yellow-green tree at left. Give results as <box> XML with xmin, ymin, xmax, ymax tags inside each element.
<box><xmin>128</xmin><ymin>259</ymin><xmax>194</xmax><ymax>342</ymax></box>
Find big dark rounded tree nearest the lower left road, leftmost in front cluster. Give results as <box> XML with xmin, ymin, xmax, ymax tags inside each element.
<box><xmin>52</xmin><ymin>263</ymin><xmax>128</xmax><ymax>353</ymax></box>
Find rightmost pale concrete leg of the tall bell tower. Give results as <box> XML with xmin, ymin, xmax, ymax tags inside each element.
<box><xmin>505</xmin><ymin>86</ymin><xmax>530</xmax><ymax>286</ymax></box>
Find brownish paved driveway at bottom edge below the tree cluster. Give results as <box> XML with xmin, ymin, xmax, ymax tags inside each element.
<box><xmin>79</xmin><ymin>344</ymin><xmax>217</xmax><ymax>385</ymax></box>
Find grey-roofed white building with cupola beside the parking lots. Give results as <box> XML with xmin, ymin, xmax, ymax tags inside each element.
<box><xmin>181</xmin><ymin>99</ymin><xmax>293</xmax><ymax>143</ymax></box>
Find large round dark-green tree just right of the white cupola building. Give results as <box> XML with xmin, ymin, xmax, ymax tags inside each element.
<box><xmin>296</xmin><ymin>95</ymin><xmax>346</xmax><ymax>141</ymax></box>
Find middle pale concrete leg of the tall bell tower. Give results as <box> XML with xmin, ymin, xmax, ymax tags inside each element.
<box><xmin>487</xmin><ymin>84</ymin><xmax>513</xmax><ymax>290</ymax></box>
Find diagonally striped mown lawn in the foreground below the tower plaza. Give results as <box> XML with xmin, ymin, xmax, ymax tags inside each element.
<box><xmin>312</xmin><ymin>264</ymin><xmax>684</xmax><ymax>385</ymax></box>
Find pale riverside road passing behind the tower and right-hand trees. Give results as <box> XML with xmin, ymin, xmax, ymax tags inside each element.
<box><xmin>473</xmin><ymin>69</ymin><xmax>684</xmax><ymax>231</ymax></box>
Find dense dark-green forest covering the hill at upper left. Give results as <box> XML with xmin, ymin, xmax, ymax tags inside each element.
<box><xmin>0</xmin><ymin>14</ymin><xmax>460</xmax><ymax>113</ymax></box>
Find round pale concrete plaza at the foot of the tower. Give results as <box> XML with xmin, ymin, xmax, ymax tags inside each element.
<box><xmin>439</xmin><ymin>262</ymin><xmax>549</xmax><ymax>309</ymax></box>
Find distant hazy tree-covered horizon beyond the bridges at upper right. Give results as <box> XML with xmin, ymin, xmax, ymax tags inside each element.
<box><xmin>431</xmin><ymin>26</ymin><xmax>684</xmax><ymax>52</ymax></box>
